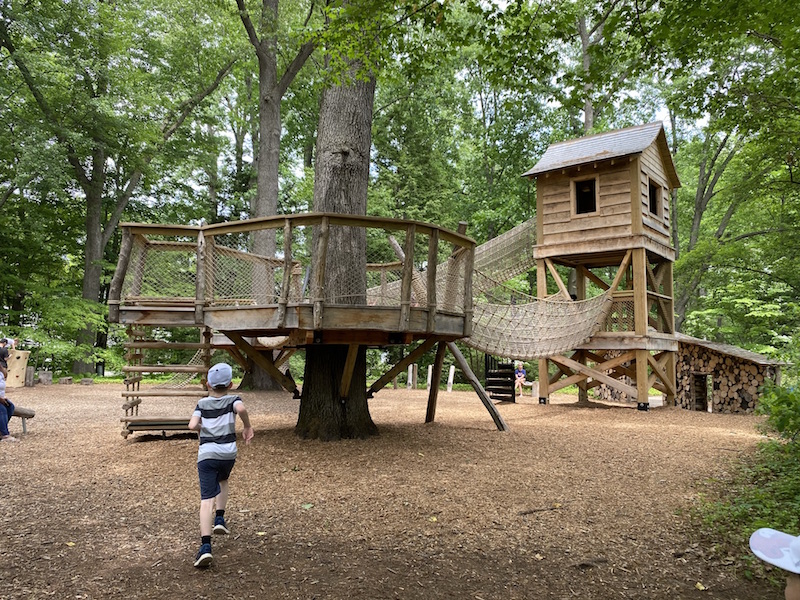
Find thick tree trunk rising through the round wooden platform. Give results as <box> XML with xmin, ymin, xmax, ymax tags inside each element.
<box><xmin>295</xmin><ymin>67</ymin><xmax>378</xmax><ymax>440</ymax></box>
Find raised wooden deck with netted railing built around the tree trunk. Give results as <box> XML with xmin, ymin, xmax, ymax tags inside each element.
<box><xmin>109</xmin><ymin>213</ymin><xmax>475</xmax><ymax>346</ymax></box>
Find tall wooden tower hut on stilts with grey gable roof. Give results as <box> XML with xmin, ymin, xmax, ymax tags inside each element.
<box><xmin>523</xmin><ymin>122</ymin><xmax>680</xmax><ymax>410</ymax></box>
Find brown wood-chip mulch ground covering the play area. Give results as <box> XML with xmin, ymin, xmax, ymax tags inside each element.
<box><xmin>0</xmin><ymin>384</ymin><xmax>783</xmax><ymax>600</ymax></box>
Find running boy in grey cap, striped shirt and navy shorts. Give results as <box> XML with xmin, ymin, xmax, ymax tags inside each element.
<box><xmin>189</xmin><ymin>363</ymin><xmax>254</xmax><ymax>567</ymax></box>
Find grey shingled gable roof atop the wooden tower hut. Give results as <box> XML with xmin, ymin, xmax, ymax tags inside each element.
<box><xmin>522</xmin><ymin>121</ymin><xmax>681</xmax><ymax>188</ymax></box>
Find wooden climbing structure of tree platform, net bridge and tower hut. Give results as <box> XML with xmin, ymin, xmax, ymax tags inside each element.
<box><xmin>109</xmin><ymin>123</ymin><xmax>680</xmax><ymax>429</ymax></box>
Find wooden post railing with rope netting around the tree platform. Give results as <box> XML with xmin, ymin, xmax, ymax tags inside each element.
<box><xmin>109</xmin><ymin>213</ymin><xmax>475</xmax><ymax>335</ymax></box>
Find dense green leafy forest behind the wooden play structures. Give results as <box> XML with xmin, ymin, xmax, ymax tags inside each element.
<box><xmin>0</xmin><ymin>0</ymin><xmax>800</xmax><ymax>380</ymax></box>
